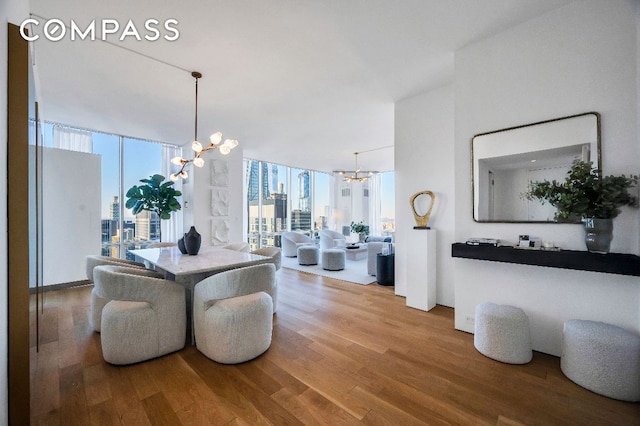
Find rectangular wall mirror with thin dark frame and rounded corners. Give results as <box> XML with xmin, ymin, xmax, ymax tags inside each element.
<box><xmin>471</xmin><ymin>112</ymin><xmax>600</xmax><ymax>222</ymax></box>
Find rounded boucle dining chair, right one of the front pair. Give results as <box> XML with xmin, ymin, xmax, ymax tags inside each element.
<box><xmin>193</xmin><ymin>263</ymin><xmax>277</xmax><ymax>364</ymax></box>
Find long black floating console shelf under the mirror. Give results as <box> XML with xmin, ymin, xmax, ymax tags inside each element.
<box><xmin>451</xmin><ymin>243</ymin><xmax>640</xmax><ymax>276</ymax></box>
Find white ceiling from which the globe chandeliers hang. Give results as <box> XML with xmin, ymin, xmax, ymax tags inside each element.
<box><xmin>30</xmin><ymin>0</ymin><xmax>571</xmax><ymax>171</ymax></box>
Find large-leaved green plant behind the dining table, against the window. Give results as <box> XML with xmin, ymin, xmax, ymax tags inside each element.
<box><xmin>125</xmin><ymin>174</ymin><xmax>182</xmax><ymax>241</ymax></box>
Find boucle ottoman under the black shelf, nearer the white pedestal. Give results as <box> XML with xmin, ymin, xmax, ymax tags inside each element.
<box><xmin>473</xmin><ymin>303</ymin><xmax>533</xmax><ymax>364</ymax></box>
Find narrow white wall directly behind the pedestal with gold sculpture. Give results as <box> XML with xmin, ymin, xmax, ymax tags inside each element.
<box><xmin>395</xmin><ymin>86</ymin><xmax>456</xmax><ymax>306</ymax></box>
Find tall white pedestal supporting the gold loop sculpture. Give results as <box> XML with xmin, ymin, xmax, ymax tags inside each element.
<box><xmin>406</xmin><ymin>229</ymin><xmax>436</xmax><ymax>311</ymax></box>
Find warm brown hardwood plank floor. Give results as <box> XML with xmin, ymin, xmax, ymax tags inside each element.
<box><xmin>31</xmin><ymin>268</ymin><xmax>640</xmax><ymax>425</ymax></box>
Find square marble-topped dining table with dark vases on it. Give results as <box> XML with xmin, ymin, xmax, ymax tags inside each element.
<box><xmin>129</xmin><ymin>246</ymin><xmax>273</xmax><ymax>344</ymax></box>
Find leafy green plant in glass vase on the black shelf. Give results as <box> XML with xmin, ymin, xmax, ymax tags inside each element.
<box><xmin>524</xmin><ymin>160</ymin><xmax>638</xmax><ymax>253</ymax></box>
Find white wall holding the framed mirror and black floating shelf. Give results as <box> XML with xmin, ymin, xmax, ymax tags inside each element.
<box><xmin>454</xmin><ymin>0</ymin><xmax>640</xmax><ymax>355</ymax></box>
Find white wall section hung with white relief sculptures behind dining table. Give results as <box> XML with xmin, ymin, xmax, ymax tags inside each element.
<box><xmin>183</xmin><ymin>146</ymin><xmax>246</xmax><ymax>246</ymax></box>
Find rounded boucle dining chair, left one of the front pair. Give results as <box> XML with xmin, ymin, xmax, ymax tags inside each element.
<box><xmin>93</xmin><ymin>266</ymin><xmax>187</xmax><ymax>365</ymax></box>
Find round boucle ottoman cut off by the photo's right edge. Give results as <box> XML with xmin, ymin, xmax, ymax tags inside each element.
<box><xmin>560</xmin><ymin>320</ymin><xmax>640</xmax><ymax>402</ymax></box>
